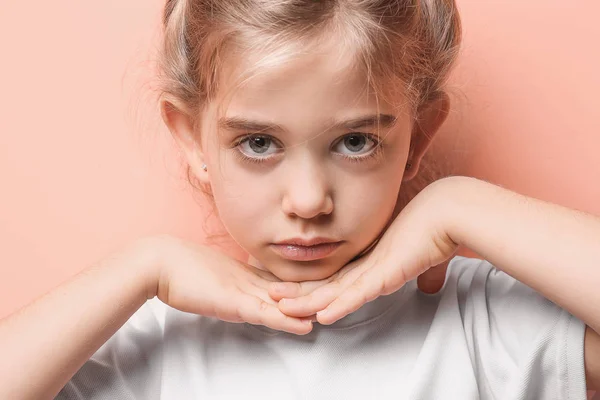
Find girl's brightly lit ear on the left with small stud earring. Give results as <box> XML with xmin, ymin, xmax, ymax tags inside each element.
<box><xmin>159</xmin><ymin>96</ymin><xmax>209</xmax><ymax>184</ymax></box>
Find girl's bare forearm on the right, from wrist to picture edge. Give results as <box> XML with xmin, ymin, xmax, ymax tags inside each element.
<box><xmin>446</xmin><ymin>178</ymin><xmax>600</xmax><ymax>332</ymax></box>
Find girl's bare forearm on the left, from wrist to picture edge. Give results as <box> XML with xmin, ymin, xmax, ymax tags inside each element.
<box><xmin>0</xmin><ymin>239</ymin><xmax>161</xmax><ymax>400</ymax></box>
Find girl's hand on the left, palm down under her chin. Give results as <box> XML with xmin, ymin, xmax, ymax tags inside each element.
<box><xmin>149</xmin><ymin>236</ymin><xmax>312</xmax><ymax>335</ymax></box>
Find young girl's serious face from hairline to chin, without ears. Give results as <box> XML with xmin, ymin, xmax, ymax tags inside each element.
<box><xmin>192</xmin><ymin>43</ymin><xmax>412</xmax><ymax>281</ymax></box>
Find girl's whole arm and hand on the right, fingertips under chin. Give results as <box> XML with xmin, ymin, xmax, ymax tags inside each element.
<box><xmin>269</xmin><ymin>177</ymin><xmax>600</xmax><ymax>390</ymax></box>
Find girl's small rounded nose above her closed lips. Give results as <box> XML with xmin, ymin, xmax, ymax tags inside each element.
<box><xmin>281</xmin><ymin>163</ymin><xmax>333</xmax><ymax>219</ymax></box>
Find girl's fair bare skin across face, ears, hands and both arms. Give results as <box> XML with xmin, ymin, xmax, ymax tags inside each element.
<box><xmin>0</xmin><ymin>45</ymin><xmax>600</xmax><ymax>399</ymax></box>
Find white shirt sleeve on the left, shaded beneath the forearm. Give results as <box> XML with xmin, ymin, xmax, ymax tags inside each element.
<box><xmin>55</xmin><ymin>298</ymin><xmax>166</xmax><ymax>400</ymax></box>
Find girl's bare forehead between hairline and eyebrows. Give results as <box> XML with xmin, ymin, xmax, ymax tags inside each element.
<box><xmin>217</xmin><ymin>42</ymin><xmax>398</xmax><ymax>122</ymax></box>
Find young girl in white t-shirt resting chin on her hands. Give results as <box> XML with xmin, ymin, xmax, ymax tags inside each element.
<box><xmin>0</xmin><ymin>0</ymin><xmax>600</xmax><ymax>399</ymax></box>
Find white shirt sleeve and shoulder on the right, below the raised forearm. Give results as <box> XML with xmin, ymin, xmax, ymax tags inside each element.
<box><xmin>445</xmin><ymin>257</ymin><xmax>586</xmax><ymax>399</ymax></box>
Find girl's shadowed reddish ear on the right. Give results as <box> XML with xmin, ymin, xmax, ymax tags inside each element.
<box><xmin>402</xmin><ymin>92</ymin><xmax>450</xmax><ymax>181</ymax></box>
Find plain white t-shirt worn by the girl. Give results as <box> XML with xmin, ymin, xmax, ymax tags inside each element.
<box><xmin>57</xmin><ymin>257</ymin><xmax>586</xmax><ymax>400</ymax></box>
